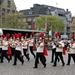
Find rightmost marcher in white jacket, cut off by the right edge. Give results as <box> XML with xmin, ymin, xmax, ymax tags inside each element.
<box><xmin>66</xmin><ymin>39</ymin><xmax>75</xmax><ymax>65</ymax></box>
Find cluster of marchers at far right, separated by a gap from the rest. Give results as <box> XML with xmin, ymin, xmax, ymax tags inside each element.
<box><xmin>51</xmin><ymin>37</ymin><xmax>75</xmax><ymax>66</ymax></box>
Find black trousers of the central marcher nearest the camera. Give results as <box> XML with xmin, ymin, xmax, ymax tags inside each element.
<box><xmin>34</xmin><ymin>53</ymin><xmax>46</xmax><ymax>68</ymax></box>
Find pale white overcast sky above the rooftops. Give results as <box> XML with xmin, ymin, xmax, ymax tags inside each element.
<box><xmin>14</xmin><ymin>0</ymin><xmax>75</xmax><ymax>16</ymax></box>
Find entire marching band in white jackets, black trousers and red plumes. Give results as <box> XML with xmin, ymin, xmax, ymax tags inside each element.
<box><xmin>0</xmin><ymin>33</ymin><xmax>75</xmax><ymax>68</ymax></box>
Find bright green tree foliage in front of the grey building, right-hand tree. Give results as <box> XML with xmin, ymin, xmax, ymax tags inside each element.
<box><xmin>35</xmin><ymin>15</ymin><xmax>65</xmax><ymax>32</ymax></box>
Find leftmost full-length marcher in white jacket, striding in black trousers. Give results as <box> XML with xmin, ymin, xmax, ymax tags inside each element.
<box><xmin>1</xmin><ymin>37</ymin><xmax>10</xmax><ymax>63</ymax></box>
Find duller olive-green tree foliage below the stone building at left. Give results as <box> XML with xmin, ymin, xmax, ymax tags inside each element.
<box><xmin>2</xmin><ymin>13</ymin><xmax>28</xmax><ymax>29</ymax></box>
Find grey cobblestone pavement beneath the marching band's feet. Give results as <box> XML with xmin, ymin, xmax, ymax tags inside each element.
<box><xmin>0</xmin><ymin>51</ymin><xmax>75</xmax><ymax>75</ymax></box>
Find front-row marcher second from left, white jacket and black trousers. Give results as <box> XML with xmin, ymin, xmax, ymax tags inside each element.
<box><xmin>13</xmin><ymin>38</ymin><xmax>24</xmax><ymax>65</ymax></box>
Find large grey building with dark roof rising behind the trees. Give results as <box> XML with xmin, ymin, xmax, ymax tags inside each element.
<box><xmin>19</xmin><ymin>4</ymin><xmax>72</xmax><ymax>38</ymax></box>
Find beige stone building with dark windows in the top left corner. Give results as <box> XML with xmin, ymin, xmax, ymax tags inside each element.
<box><xmin>0</xmin><ymin>0</ymin><xmax>16</xmax><ymax>21</ymax></box>
